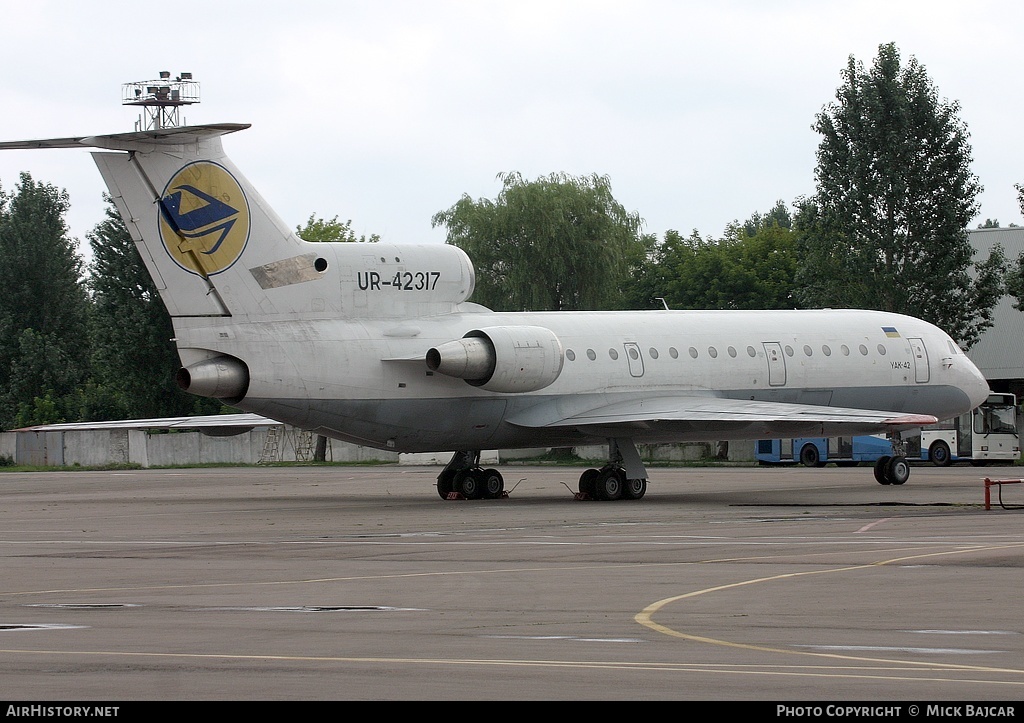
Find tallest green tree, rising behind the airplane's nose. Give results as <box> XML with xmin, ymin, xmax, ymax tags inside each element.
<box><xmin>795</xmin><ymin>43</ymin><xmax>1005</xmax><ymax>347</ymax></box>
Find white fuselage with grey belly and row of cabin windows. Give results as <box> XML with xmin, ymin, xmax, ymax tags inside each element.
<box><xmin>172</xmin><ymin>307</ymin><xmax>988</xmax><ymax>452</ymax></box>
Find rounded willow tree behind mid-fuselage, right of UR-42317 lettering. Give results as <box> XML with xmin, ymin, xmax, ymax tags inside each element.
<box><xmin>433</xmin><ymin>173</ymin><xmax>642</xmax><ymax>311</ymax></box>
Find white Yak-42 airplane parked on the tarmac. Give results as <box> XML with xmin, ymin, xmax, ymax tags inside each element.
<box><xmin>0</xmin><ymin>124</ymin><xmax>989</xmax><ymax>501</ymax></box>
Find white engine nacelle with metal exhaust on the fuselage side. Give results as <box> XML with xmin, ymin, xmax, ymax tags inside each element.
<box><xmin>427</xmin><ymin>327</ymin><xmax>564</xmax><ymax>392</ymax></box>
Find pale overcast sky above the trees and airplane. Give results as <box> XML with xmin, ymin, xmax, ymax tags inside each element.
<box><xmin>0</xmin><ymin>0</ymin><xmax>1024</xmax><ymax>262</ymax></box>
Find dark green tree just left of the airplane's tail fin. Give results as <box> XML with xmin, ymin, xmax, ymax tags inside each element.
<box><xmin>89</xmin><ymin>198</ymin><xmax>222</xmax><ymax>420</ymax></box>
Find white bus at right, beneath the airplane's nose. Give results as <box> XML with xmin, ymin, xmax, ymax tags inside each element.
<box><xmin>921</xmin><ymin>393</ymin><xmax>1021</xmax><ymax>467</ymax></box>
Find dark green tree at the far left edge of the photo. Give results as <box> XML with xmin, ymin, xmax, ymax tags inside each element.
<box><xmin>0</xmin><ymin>173</ymin><xmax>89</xmax><ymax>427</ymax></box>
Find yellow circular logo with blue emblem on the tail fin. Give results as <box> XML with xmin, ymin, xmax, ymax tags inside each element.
<box><xmin>159</xmin><ymin>161</ymin><xmax>250</xmax><ymax>277</ymax></box>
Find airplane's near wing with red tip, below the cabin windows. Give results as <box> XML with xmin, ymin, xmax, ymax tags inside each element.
<box><xmin>508</xmin><ymin>395</ymin><xmax>938</xmax><ymax>439</ymax></box>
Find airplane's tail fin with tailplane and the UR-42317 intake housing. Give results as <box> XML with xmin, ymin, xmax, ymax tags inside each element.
<box><xmin>0</xmin><ymin>124</ymin><xmax>474</xmax><ymax>321</ymax></box>
